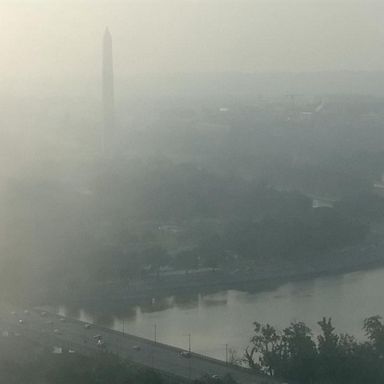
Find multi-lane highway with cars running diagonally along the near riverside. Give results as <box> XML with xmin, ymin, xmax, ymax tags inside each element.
<box><xmin>0</xmin><ymin>310</ymin><xmax>276</xmax><ymax>384</ymax></box>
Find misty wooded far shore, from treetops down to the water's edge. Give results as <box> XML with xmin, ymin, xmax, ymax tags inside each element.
<box><xmin>0</xmin><ymin>153</ymin><xmax>384</xmax><ymax>306</ymax></box>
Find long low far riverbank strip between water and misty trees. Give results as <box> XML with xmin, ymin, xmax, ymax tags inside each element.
<box><xmin>51</xmin><ymin>241</ymin><xmax>384</xmax><ymax>311</ymax></box>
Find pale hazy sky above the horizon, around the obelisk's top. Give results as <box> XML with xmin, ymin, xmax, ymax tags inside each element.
<box><xmin>0</xmin><ymin>0</ymin><xmax>384</xmax><ymax>84</ymax></box>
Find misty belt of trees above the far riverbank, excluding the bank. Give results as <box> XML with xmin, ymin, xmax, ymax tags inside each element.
<box><xmin>0</xmin><ymin>161</ymin><xmax>384</xmax><ymax>304</ymax></box>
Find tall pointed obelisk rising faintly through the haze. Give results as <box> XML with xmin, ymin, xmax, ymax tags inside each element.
<box><xmin>102</xmin><ymin>28</ymin><xmax>115</xmax><ymax>153</ymax></box>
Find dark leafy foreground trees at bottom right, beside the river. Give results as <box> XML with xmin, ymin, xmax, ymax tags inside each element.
<box><xmin>245</xmin><ymin>316</ymin><xmax>384</xmax><ymax>384</ymax></box>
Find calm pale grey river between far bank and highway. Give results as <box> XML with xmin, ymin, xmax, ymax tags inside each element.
<box><xmin>59</xmin><ymin>268</ymin><xmax>384</xmax><ymax>360</ymax></box>
